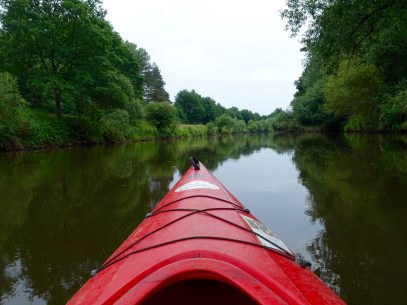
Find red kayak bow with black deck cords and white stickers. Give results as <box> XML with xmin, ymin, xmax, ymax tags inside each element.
<box><xmin>68</xmin><ymin>159</ymin><xmax>345</xmax><ymax>305</ymax></box>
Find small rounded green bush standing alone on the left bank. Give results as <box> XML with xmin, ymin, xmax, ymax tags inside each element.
<box><xmin>145</xmin><ymin>102</ymin><xmax>177</xmax><ymax>136</ymax></box>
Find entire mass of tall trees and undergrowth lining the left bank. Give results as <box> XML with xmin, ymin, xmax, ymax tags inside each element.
<box><xmin>0</xmin><ymin>0</ymin><xmax>286</xmax><ymax>149</ymax></box>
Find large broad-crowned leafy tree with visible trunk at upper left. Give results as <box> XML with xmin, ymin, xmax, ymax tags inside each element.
<box><xmin>0</xmin><ymin>0</ymin><xmax>114</xmax><ymax>116</ymax></box>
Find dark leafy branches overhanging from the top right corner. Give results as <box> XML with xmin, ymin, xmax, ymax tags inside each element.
<box><xmin>281</xmin><ymin>0</ymin><xmax>407</xmax><ymax>68</ymax></box>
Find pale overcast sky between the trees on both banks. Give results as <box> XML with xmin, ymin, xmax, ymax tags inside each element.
<box><xmin>104</xmin><ymin>0</ymin><xmax>303</xmax><ymax>114</ymax></box>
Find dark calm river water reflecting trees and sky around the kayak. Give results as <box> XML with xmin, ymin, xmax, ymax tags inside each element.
<box><xmin>0</xmin><ymin>135</ymin><xmax>407</xmax><ymax>305</ymax></box>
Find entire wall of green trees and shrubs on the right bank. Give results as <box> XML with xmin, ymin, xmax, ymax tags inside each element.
<box><xmin>277</xmin><ymin>0</ymin><xmax>407</xmax><ymax>131</ymax></box>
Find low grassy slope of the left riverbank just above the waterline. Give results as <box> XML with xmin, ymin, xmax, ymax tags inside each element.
<box><xmin>0</xmin><ymin>111</ymin><xmax>268</xmax><ymax>152</ymax></box>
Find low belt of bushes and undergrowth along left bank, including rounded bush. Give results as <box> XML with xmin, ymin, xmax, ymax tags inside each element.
<box><xmin>0</xmin><ymin>73</ymin><xmax>282</xmax><ymax>150</ymax></box>
